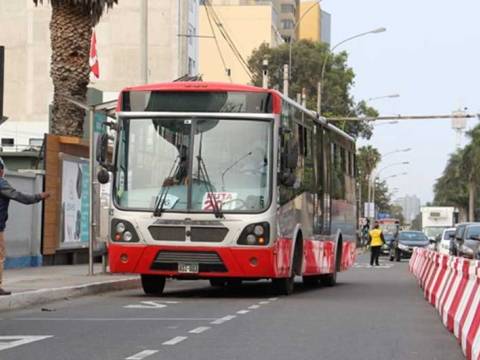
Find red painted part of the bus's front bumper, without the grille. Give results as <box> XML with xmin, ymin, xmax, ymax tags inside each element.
<box><xmin>108</xmin><ymin>243</ymin><xmax>287</xmax><ymax>279</ymax></box>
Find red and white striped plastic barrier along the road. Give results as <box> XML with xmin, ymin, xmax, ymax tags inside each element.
<box><xmin>409</xmin><ymin>248</ymin><xmax>480</xmax><ymax>360</ymax></box>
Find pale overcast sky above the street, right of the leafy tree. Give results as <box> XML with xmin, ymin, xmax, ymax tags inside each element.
<box><xmin>322</xmin><ymin>0</ymin><xmax>480</xmax><ymax>204</ymax></box>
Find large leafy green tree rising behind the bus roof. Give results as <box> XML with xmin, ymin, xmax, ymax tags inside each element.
<box><xmin>248</xmin><ymin>40</ymin><xmax>378</xmax><ymax>139</ymax></box>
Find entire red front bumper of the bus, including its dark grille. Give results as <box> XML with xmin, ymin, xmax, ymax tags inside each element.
<box><xmin>108</xmin><ymin>243</ymin><xmax>285</xmax><ymax>279</ymax></box>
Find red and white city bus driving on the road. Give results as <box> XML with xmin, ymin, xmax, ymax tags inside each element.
<box><xmin>99</xmin><ymin>82</ymin><xmax>357</xmax><ymax>294</ymax></box>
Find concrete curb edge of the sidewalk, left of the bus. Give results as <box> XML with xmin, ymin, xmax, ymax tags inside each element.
<box><xmin>0</xmin><ymin>278</ymin><xmax>140</xmax><ymax>312</ymax></box>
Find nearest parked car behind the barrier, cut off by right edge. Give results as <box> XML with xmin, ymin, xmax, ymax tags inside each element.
<box><xmin>450</xmin><ymin>223</ymin><xmax>480</xmax><ymax>259</ymax></box>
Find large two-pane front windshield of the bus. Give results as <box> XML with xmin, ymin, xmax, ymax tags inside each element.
<box><xmin>111</xmin><ymin>117</ymin><xmax>273</xmax><ymax>212</ymax></box>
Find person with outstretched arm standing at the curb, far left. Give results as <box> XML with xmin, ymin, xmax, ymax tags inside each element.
<box><xmin>0</xmin><ymin>158</ymin><xmax>50</xmax><ymax>296</ymax></box>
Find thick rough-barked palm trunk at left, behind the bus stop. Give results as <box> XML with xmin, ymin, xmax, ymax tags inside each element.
<box><xmin>33</xmin><ymin>0</ymin><xmax>118</xmax><ymax>136</ymax></box>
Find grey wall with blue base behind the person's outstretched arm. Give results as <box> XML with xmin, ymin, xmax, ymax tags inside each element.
<box><xmin>5</xmin><ymin>172</ymin><xmax>43</xmax><ymax>268</ymax></box>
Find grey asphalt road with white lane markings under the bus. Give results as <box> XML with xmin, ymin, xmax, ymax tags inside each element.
<box><xmin>0</xmin><ymin>256</ymin><xmax>464</xmax><ymax>360</ymax></box>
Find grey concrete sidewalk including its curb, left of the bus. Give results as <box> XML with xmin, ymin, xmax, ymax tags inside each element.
<box><xmin>0</xmin><ymin>264</ymin><xmax>140</xmax><ymax>312</ymax></box>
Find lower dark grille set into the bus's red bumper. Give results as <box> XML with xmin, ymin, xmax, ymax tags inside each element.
<box><xmin>151</xmin><ymin>251</ymin><xmax>227</xmax><ymax>272</ymax></box>
